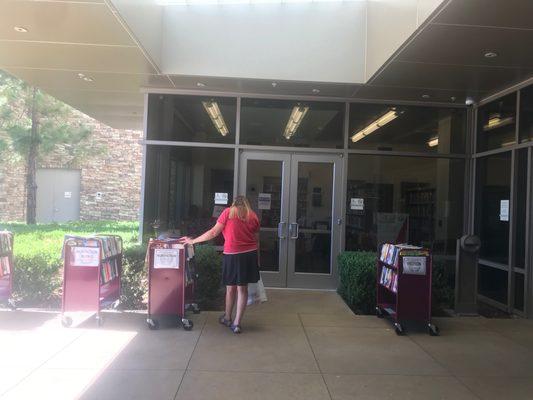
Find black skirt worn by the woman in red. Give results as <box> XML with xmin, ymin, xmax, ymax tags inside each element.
<box><xmin>222</xmin><ymin>250</ymin><xmax>260</xmax><ymax>286</ymax></box>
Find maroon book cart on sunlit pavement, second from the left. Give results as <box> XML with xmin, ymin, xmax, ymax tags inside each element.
<box><xmin>61</xmin><ymin>235</ymin><xmax>122</xmax><ymax>327</ymax></box>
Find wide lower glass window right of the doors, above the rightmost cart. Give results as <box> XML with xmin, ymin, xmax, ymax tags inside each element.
<box><xmin>346</xmin><ymin>155</ymin><xmax>465</xmax><ymax>255</ymax></box>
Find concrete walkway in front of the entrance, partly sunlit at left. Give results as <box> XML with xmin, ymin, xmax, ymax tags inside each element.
<box><xmin>0</xmin><ymin>290</ymin><xmax>533</xmax><ymax>400</ymax></box>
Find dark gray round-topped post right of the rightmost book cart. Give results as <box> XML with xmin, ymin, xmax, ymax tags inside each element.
<box><xmin>455</xmin><ymin>235</ymin><xmax>481</xmax><ymax>315</ymax></box>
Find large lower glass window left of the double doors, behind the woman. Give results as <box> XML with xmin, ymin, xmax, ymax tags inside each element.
<box><xmin>144</xmin><ymin>146</ymin><xmax>234</xmax><ymax>241</ymax></box>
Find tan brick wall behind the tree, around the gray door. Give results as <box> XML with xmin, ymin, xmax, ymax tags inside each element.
<box><xmin>0</xmin><ymin>113</ymin><xmax>142</xmax><ymax>221</ymax></box>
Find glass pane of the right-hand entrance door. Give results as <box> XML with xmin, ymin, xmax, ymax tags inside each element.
<box><xmin>294</xmin><ymin>162</ymin><xmax>333</xmax><ymax>274</ymax></box>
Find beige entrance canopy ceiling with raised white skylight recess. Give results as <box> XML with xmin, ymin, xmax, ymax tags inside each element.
<box><xmin>0</xmin><ymin>0</ymin><xmax>533</xmax><ymax>129</ymax></box>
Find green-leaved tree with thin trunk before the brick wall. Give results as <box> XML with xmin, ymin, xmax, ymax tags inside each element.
<box><xmin>0</xmin><ymin>71</ymin><xmax>91</xmax><ymax>224</ymax></box>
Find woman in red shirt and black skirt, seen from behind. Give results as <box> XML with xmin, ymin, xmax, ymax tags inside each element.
<box><xmin>185</xmin><ymin>196</ymin><xmax>260</xmax><ymax>333</ymax></box>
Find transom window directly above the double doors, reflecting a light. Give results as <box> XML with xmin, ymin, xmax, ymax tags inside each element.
<box><xmin>240</xmin><ymin>99</ymin><xmax>345</xmax><ymax>148</ymax></box>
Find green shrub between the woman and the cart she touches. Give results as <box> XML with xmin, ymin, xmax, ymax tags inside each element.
<box><xmin>194</xmin><ymin>245</ymin><xmax>222</xmax><ymax>310</ymax></box>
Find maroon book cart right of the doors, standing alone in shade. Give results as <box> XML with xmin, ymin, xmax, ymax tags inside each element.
<box><xmin>376</xmin><ymin>244</ymin><xmax>439</xmax><ymax>336</ymax></box>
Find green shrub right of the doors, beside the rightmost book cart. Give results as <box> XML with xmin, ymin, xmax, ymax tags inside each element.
<box><xmin>337</xmin><ymin>251</ymin><xmax>376</xmax><ymax>314</ymax></box>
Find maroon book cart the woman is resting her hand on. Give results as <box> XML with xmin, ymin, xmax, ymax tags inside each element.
<box><xmin>146</xmin><ymin>239</ymin><xmax>200</xmax><ymax>331</ymax></box>
